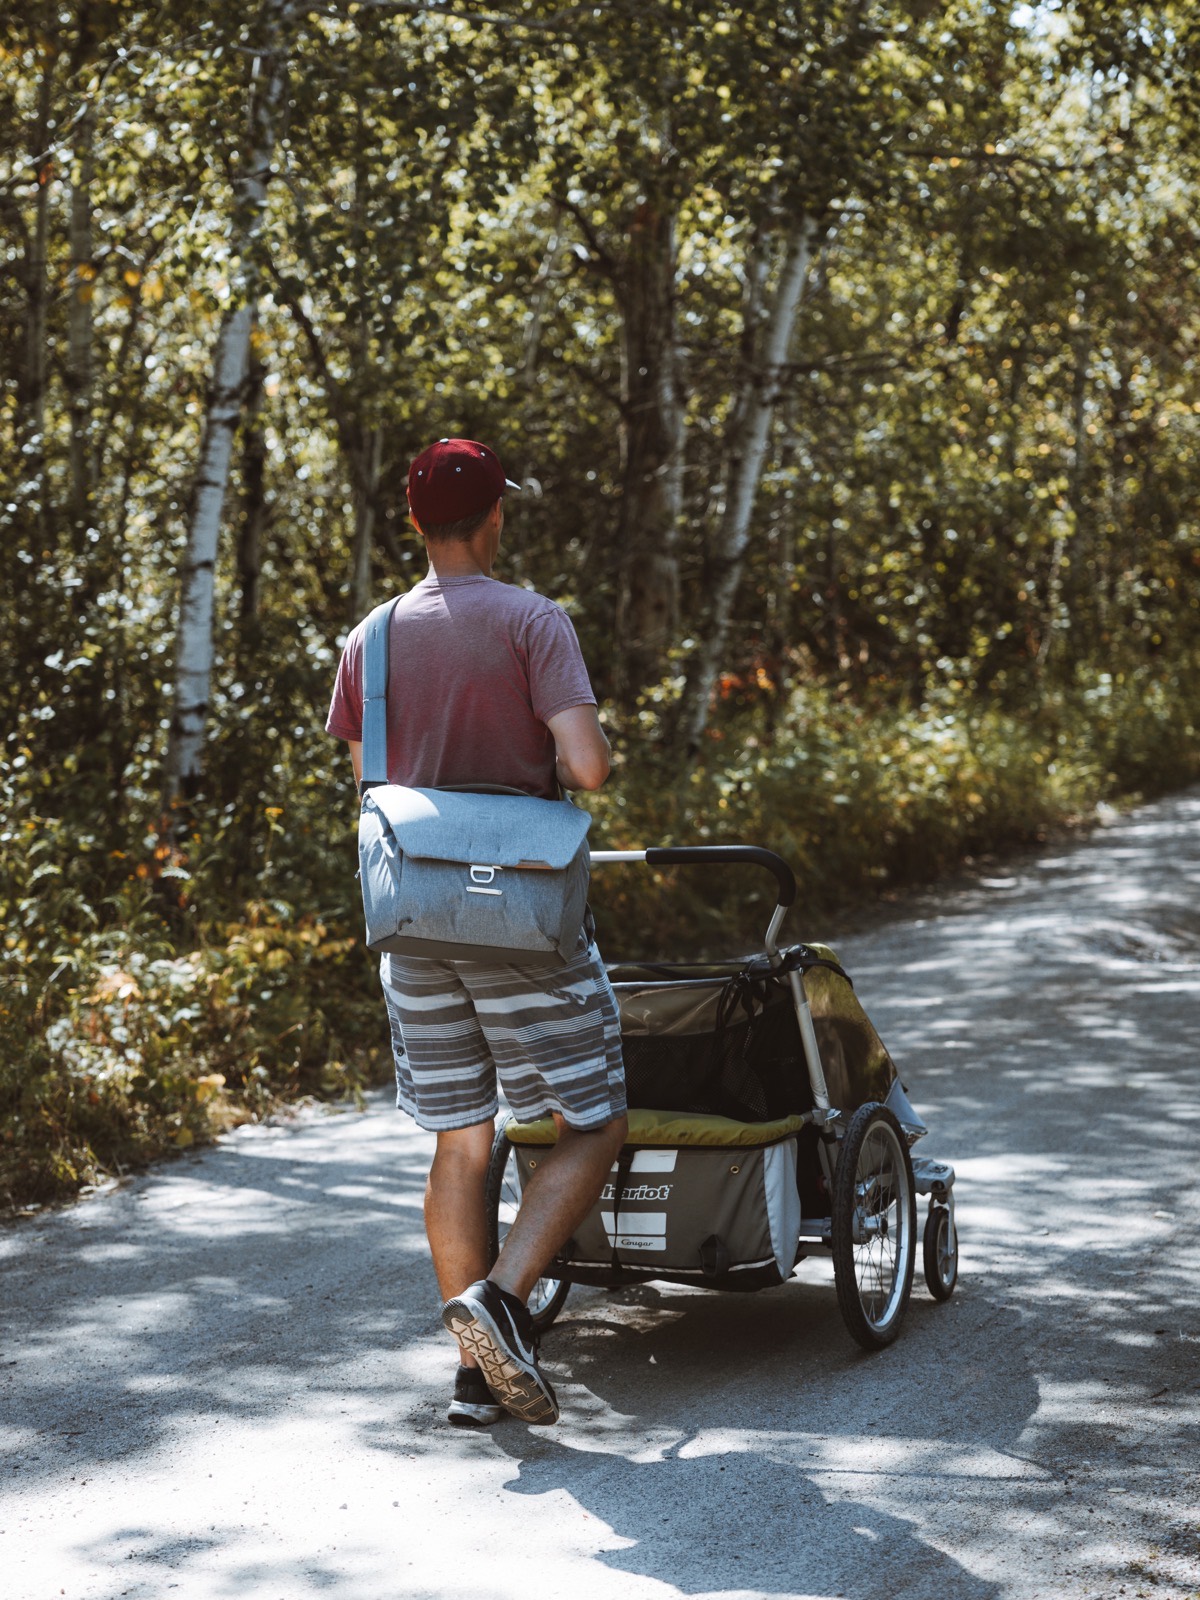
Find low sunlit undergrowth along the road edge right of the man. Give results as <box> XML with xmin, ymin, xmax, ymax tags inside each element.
<box><xmin>589</xmin><ymin>670</ymin><xmax>1200</xmax><ymax>960</ymax></box>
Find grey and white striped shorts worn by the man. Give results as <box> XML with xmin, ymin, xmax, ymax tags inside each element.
<box><xmin>379</xmin><ymin>944</ymin><xmax>626</xmax><ymax>1133</ymax></box>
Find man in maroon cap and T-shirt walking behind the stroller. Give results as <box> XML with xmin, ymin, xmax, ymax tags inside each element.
<box><xmin>326</xmin><ymin>438</ymin><xmax>626</xmax><ymax>1426</ymax></box>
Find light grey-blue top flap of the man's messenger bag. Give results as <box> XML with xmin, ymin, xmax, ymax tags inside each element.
<box><xmin>363</xmin><ymin>784</ymin><xmax>592</xmax><ymax>872</ymax></box>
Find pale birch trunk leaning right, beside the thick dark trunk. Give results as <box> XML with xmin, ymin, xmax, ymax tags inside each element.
<box><xmin>674</xmin><ymin>218</ymin><xmax>818</xmax><ymax>758</ymax></box>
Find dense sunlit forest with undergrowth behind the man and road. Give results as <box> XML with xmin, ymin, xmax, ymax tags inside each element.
<box><xmin>0</xmin><ymin>0</ymin><xmax>1200</xmax><ymax>1206</ymax></box>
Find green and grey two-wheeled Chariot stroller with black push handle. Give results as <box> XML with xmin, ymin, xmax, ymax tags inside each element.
<box><xmin>488</xmin><ymin>845</ymin><xmax>958</xmax><ymax>1350</ymax></box>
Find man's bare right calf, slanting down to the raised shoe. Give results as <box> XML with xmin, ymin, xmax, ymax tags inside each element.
<box><xmin>489</xmin><ymin>1115</ymin><xmax>629</xmax><ymax>1301</ymax></box>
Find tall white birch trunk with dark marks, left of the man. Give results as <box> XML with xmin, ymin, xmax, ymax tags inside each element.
<box><xmin>163</xmin><ymin>0</ymin><xmax>294</xmax><ymax>808</ymax></box>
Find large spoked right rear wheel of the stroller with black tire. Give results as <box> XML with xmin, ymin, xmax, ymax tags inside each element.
<box><xmin>830</xmin><ymin>1101</ymin><xmax>917</xmax><ymax>1350</ymax></box>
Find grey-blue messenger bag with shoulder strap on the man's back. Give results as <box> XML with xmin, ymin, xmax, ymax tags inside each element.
<box><xmin>358</xmin><ymin>600</ymin><xmax>592</xmax><ymax>966</ymax></box>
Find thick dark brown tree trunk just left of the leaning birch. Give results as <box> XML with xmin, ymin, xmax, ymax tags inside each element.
<box><xmin>616</xmin><ymin>202</ymin><xmax>683</xmax><ymax>704</ymax></box>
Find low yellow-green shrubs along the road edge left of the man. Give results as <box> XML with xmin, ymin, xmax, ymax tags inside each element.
<box><xmin>0</xmin><ymin>906</ymin><xmax>390</xmax><ymax>1203</ymax></box>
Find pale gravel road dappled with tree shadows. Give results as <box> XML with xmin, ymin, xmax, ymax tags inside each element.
<box><xmin>0</xmin><ymin>790</ymin><xmax>1200</xmax><ymax>1600</ymax></box>
